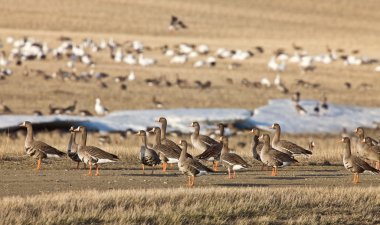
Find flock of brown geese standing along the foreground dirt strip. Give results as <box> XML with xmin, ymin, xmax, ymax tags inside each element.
<box><xmin>20</xmin><ymin>117</ymin><xmax>380</xmax><ymax>186</ymax></box>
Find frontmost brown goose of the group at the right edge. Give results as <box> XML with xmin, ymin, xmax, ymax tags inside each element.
<box><xmin>342</xmin><ymin>137</ymin><xmax>380</xmax><ymax>184</ymax></box>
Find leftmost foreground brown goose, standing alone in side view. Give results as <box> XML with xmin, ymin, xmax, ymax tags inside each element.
<box><xmin>20</xmin><ymin>121</ymin><xmax>66</xmax><ymax>171</ymax></box>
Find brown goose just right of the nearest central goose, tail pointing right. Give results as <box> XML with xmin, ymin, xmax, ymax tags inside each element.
<box><xmin>220</xmin><ymin>136</ymin><xmax>250</xmax><ymax>179</ymax></box>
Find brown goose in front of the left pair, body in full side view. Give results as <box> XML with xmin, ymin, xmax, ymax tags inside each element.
<box><xmin>74</xmin><ymin>126</ymin><xmax>119</xmax><ymax>176</ymax></box>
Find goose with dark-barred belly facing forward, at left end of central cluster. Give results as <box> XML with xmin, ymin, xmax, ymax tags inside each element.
<box><xmin>137</xmin><ymin>130</ymin><xmax>161</xmax><ymax>174</ymax></box>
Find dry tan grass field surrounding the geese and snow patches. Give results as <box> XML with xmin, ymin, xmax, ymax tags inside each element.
<box><xmin>0</xmin><ymin>0</ymin><xmax>380</xmax><ymax>224</ymax></box>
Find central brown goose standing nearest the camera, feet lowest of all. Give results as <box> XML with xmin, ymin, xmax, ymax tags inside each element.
<box><xmin>178</xmin><ymin>140</ymin><xmax>208</xmax><ymax>187</ymax></box>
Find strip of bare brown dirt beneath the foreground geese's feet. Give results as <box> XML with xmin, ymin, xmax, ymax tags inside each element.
<box><xmin>0</xmin><ymin>160</ymin><xmax>380</xmax><ymax>197</ymax></box>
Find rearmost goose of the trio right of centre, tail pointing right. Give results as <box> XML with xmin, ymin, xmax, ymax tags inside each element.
<box><xmin>272</xmin><ymin>123</ymin><xmax>313</xmax><ymax>156</ymax></box>
